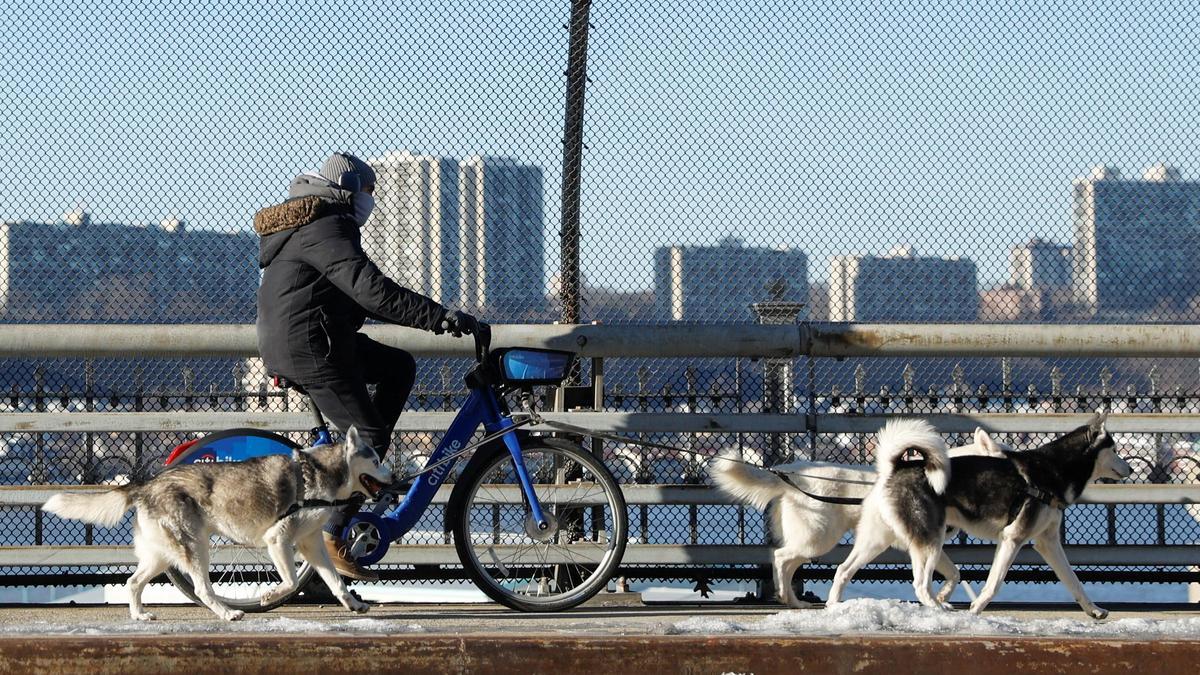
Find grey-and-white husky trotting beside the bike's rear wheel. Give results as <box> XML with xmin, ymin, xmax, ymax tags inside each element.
<box><xmin>42</xmin><ymin>426</ymin><xmax>392</xmax><ymax>621</ymax></box>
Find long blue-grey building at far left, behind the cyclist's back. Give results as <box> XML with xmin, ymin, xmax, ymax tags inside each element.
<box><xmin>0</xmin><ymin>211</ymin><xmax>258</xmax><ymax>323</ymax></box>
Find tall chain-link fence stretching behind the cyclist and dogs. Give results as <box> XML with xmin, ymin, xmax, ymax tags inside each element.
<box><xmin>0</xmin><ymin>0</ymin><xmax>1200</xmax><ymax>590</ymax></box>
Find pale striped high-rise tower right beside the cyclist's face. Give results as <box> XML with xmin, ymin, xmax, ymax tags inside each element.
<box><xmin>362</xmin><ymin>151</ymin><xmax>461</xmax><ymax>305</ymax></box>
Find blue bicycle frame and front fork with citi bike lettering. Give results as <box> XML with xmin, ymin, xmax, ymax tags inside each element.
<box><xmin>358</xmin><ymin>386</ymin><xmax>548</xmax><ymax>542</ymax></box>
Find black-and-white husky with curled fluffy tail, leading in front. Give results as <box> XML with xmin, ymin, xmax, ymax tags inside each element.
<box><xmin>829</xmin><ymin>416</ymin><xmax>1132</xmax><ymax>619</ymax></box>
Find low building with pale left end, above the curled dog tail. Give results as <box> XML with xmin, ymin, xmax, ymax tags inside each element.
<box><xmin>829</xmin><ymin>246</ymin><xmax>979</xmax><ymax>322</ymax></box>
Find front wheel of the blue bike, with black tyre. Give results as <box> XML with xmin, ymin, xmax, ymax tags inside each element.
<box><xmin>451</xmin><ymin>438</ymin><xmax>626</xmax><ymax>611</ymax></box>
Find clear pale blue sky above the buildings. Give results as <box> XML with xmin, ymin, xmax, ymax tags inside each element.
<box><xmin>0</xmin><ymin>0</ymin><xmax>1200</xmax><ymax>288</ymax></box>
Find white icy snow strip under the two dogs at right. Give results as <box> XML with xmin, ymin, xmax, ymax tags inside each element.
<box><xmin>666</xmin><ymin>598</ymin><xmax>1200</xmax><ymax>638</ymax></box>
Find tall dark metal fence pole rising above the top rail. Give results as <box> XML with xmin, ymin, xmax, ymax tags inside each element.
<box><xmin>558</xmin><ymin>0</ymin><xmax>592</xmax><ymax>324</ymax></box>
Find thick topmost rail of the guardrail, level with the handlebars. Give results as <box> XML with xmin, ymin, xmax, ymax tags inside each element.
<box><xmin>0</xmin><ymin>323</ymin><xmax>1200</xmax><ymax>358</ymax></box>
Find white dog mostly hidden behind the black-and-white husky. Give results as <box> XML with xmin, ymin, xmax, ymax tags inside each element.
<box><xmin>709</xmin><ymin>429</ymin><xmax>1006</xmax><ymax>608</ymax></box>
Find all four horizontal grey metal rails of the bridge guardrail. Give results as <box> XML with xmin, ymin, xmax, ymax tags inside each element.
<box><xmin>0</xmin><ymin>323</ymin><xmax>1200</xmax><ymax>578</ymax></box>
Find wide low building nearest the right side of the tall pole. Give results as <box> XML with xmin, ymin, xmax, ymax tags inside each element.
<box><xmin>654</xmin><ymin>237</ymin><xmax>809</xmax><ymax>323</ymax></box>
